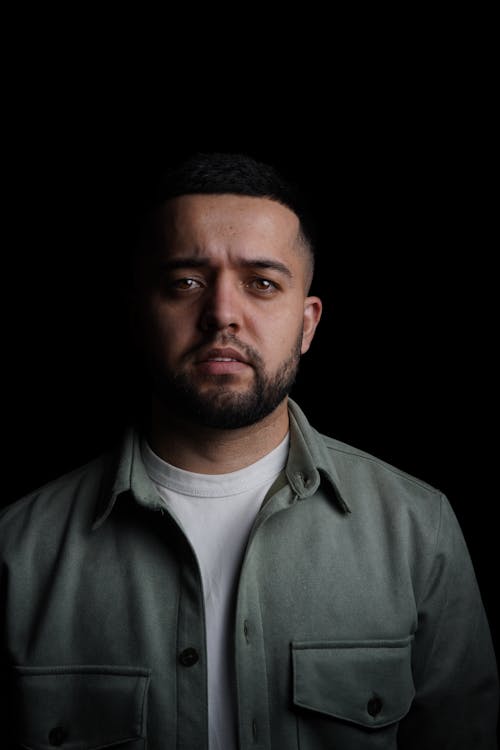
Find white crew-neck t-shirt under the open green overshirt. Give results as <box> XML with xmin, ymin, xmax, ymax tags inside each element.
<box><xmin>141</xmin><ymin>435</ymin><xmax>289</xmax><ymax>750</ymax></box>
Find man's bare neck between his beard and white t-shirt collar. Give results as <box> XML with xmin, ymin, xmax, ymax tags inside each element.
<box><xmin>149</xmin><ymin>398</ymin><xmax>288</xmax><ymax>474</ymax></box>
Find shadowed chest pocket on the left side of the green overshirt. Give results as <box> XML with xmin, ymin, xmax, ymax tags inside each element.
<box><xmin>9</xmin><ymin>666</ymin><xmax>150</xmax><ymax>750</ymax></box>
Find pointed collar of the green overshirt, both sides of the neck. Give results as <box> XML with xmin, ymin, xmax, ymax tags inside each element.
<box><xmin>92</xmin><ymin>398</ymin><xmax>350</xmax><ymax>529</ymax></box>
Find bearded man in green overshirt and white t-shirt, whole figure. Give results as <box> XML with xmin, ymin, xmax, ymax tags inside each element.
<box><xmin>0</xmin><ymin>154</ymin><xmax>498</xmax><ymax>750</ymax></box>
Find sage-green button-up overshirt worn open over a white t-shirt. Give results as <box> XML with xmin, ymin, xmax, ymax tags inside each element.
<box><xmin>0</xmin><ymin>401</ymin><xmax>498</xmax><ymax>750</ymax></box>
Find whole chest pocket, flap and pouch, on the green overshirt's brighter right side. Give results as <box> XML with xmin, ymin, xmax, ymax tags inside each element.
<box><xmin>292</xmin><ymin>637</ymin><xmax>415</xmax><ymax>748</ymax></box>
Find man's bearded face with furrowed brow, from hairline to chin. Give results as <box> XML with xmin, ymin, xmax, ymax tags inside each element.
<box><xmin>135</xmin><ymin>195</ymin><xmax>321</xmax><ymax>429</ymax></box>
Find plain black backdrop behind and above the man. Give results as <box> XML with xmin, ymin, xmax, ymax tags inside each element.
<box><xmin>2</xmin><ymin>18</ymin><xmax>498</xmax><ymax>656</ymax></box>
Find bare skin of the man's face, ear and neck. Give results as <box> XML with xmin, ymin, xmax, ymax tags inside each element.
<box><xmin>135</xmin><ymin>194</ymin><xmax>322</xmax><ymax>474</ymax></box>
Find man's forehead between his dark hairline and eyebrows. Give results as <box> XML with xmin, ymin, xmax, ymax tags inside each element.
<box><xmin>151</xmin><ymin>194</ymin><xmax>299</xmax><ymax>255</ymax></box>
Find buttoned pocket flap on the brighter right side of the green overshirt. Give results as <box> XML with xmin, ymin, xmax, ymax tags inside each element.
<box><xmin>292</xmin><ymin>637</ymin><xmax>415</xmax><ymax>727</ymax></box>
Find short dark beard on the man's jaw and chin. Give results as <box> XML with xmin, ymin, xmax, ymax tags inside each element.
<box><xmin>148</xmin><ymin>332</ymin><xmax>302</xmax><ymax>430</ymax></box>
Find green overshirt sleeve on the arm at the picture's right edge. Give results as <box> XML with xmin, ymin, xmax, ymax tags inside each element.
<box><xmin>398</xmin><ymin>496</ymin><xmax>498</xmax><ymax>750</ymax></box>
